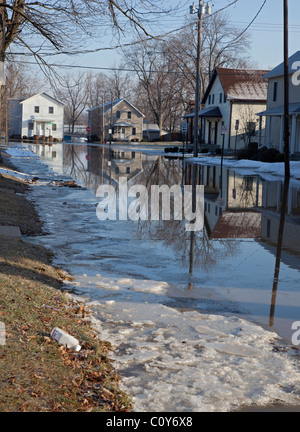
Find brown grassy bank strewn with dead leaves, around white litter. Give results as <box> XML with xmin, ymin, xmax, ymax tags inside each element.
<box><xmin>0</xmin><ymin>155</ymin><xmax>132</xmax><ymax>412</ymax></box>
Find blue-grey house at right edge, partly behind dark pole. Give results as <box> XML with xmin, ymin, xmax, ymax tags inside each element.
<box><xmin>258</xmin><ymin>51</ymin><xmax>300</xmax><ymax>155</ymax></box>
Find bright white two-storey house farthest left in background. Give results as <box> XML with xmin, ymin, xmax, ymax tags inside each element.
<box><xmin>9</xmin><ymin>93</ymin><xmax>64</xmax><ymax>140</ymax></box>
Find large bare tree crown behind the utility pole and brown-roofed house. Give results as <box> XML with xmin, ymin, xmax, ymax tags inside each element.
<box><xmin>124</xmin><ymin>13</ymin><xmax>250</xmax><ymax>135</ymax></box>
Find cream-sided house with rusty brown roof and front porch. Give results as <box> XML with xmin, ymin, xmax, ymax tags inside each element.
<box><xmin>185</xmin><ymin>67</ymin><xmax>267</xmax><ymax>150</ymax></box>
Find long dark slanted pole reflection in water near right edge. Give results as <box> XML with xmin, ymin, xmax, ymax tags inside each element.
<box><xmin>270</xmin><ymin>177</ymin><xmax>290</xmax><ymax>327</ymax></box>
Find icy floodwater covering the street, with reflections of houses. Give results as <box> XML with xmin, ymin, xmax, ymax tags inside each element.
<box><xmin>3</xmin><ymin>143</ymin><xmax>300</xmax><ymax>412</ymax></box>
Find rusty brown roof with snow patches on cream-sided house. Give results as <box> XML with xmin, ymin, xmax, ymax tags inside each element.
<box><xmin>202</xmin><ymin>67</ymin><xmax>268</xmax><ymax>103</ymax></box>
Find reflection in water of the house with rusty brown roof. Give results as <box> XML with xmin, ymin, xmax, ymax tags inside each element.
<box><xmin>188</xmin><ymin>165</ymin><xmax>262</xmax><ymax>239</ymax></box>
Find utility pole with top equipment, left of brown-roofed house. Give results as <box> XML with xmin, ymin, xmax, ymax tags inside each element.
<box><xmin>190</xmin><ymin>0</ymin><xmax>211</xmax><ymax>157</ymax></box>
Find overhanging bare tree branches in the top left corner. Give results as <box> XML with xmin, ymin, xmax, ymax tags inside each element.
<box><xmin>0</xmin><ymin>0</ymin><xmax>180</xmax><ymax>61</ymax></box>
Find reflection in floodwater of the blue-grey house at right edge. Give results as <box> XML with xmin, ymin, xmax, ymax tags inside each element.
<box><xmin>260</xmin><ymin>181</ymin><xmax>300</xmax><ymax>252</ymax></box>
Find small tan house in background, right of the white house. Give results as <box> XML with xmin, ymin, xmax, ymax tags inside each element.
<box><xmin>88</xmin><ymin>99</ymin><xmax>144</xmax><ymax>142</ymax></box>
